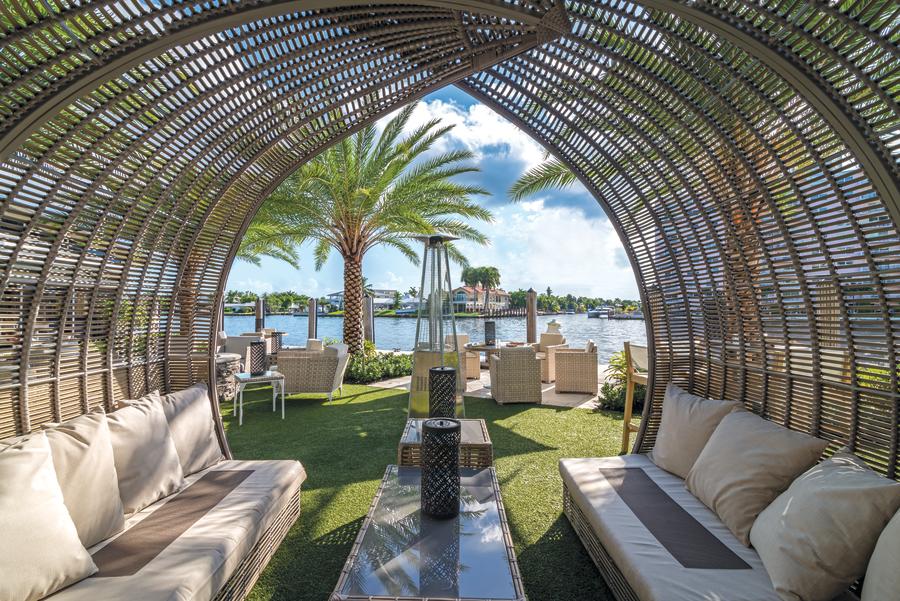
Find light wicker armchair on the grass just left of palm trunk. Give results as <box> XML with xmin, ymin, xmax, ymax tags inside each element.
<box><xmin>278</xmin><ymin>344</ymin><xmax>350</xmax><ymax>401</ymax></box>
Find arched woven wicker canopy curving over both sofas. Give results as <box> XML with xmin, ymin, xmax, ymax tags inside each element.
<box><xmin>0</xmin><ymin>0</ymin><xmax>900</xmax><ymax>477</ymax></box>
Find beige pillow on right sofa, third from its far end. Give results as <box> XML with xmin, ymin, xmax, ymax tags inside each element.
<box><xmin>750</xmin><ymin>453</ymin><xmax>900</xmax><ymax>601</ymax></box>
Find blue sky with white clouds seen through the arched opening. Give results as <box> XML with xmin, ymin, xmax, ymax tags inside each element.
<box><xmin>228</xmin><ymin>87</ymin><xmax>637</xmax><ymax>298</ymax></box>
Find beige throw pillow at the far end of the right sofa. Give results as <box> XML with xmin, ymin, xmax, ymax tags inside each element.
<box><xmin>650</xmin><ymin>383</ymin><xmax>743</xmax><ymax>478</ymax></box>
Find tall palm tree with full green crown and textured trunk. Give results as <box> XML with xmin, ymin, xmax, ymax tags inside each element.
<box><xmin>239</xmin><ymin>105</ymin><xmax>493</xmax><ymax>353</ymax></box>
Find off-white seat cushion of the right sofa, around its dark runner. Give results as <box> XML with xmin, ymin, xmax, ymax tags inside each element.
<box><xmin>559</xmin><ymin>455</ymin><xmax>779</xmax><ymax>601</ymax></box>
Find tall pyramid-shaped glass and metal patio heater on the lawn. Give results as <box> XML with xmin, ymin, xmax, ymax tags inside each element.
<box><xmin>409</xmin><ymin>235</ymin><xmax>465</xmax><ymax>417</ymax></box>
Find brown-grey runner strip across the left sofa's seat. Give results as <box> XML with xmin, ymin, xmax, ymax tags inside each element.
<box><xmin>93</xmin><ymin>470</ymin><xmax>253</xmax><ymax>578</ymax></box>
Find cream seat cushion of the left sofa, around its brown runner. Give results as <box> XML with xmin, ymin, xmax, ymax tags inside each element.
<box><xmin>51</xmin><ymin>461</ymin><xmax>306</xmax><ymax>601</ymax></box>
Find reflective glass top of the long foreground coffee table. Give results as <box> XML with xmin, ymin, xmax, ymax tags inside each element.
<box><xmin>331</xmin><ymin>465</ymin><xmax>525</xmax><ymax>601</ymax></box>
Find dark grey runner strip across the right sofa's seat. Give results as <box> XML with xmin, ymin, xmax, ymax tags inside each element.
<box><xmin>604</xmin><ymin>468</ymin><xmax>751</xmax><ymax>570</ymax></box>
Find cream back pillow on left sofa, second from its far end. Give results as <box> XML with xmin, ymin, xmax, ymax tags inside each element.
<box><xmin>107</xmin><ymin>391</ymin><xmax>184</xmax><ymax>513</ymax></box>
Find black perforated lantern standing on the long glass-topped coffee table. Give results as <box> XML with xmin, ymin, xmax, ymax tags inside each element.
<box><xmin>421</xmin><ymin>419</ymin><xmax>460</xmax><ymax>518</ymax></box>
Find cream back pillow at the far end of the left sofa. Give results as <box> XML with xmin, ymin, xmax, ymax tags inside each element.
<box><xmin>162</xmin><ymin>382</ymin><xmax>224</xmax><ymax>476</ymax></box>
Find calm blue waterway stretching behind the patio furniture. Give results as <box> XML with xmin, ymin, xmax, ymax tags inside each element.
<box><xmin>225</xmin><ymin>313</ymin><xmax>647</xmax><ymax>363</ymax></box>
